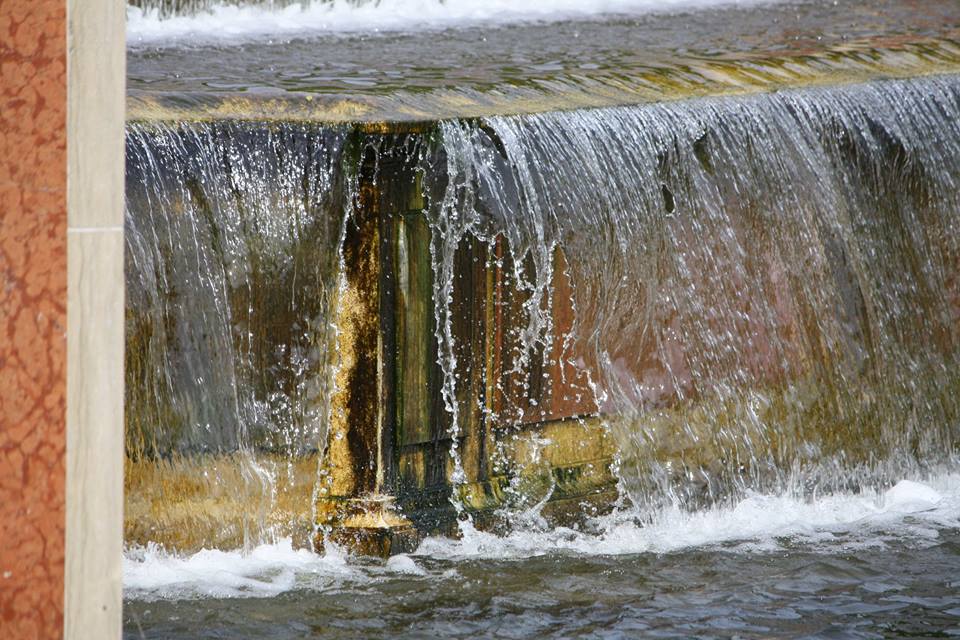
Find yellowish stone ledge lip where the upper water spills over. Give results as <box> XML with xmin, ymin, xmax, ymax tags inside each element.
<box><xmin>127</xmin><ymin>34</ymin><xmax>960</xmax><ymax>125</ymax></box>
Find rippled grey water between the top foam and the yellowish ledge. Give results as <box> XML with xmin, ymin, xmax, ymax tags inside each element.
<box><xmin>127</xmin><ymin>0</ymin><xmax>960</xmax><ymax>96</ymax></box>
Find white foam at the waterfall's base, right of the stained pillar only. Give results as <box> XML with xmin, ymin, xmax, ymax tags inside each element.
<box><xmin>417</xmin><ymin>474</ymin><xmax>960</xmax><ymax>559</ymax></box>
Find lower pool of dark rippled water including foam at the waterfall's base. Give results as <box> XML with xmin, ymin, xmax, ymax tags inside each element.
<box><xmin>124</xmin><ymin>473</ymin><xmax>960</xmax><ymax>639</ymax></box>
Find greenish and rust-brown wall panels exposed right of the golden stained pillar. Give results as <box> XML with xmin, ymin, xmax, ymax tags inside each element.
<box><xmin>396</xmin><ymin>225</ymin><xmax>597</xmax><ymax>496</ymax></box>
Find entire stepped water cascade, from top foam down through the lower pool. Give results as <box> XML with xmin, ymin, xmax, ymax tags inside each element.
<box><xmin>118</xmin><ymin>0</ymin><xmax>960</xmax><ymax>640</ymax></box>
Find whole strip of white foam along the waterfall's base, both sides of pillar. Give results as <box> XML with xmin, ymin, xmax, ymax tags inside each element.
<box><xmin>123</xmin><ymin>474</ymin><xmax>960</xmax><ymax>600</ymax></box>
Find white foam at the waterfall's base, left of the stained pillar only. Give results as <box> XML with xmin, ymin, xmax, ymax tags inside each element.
<box><xmin>123</xmin><ymin>538</ymin><xmax>366</xmax><ymax>600</ymax></box>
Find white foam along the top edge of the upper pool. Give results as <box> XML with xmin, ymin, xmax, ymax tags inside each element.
<box><xmin>127</xmin><ymin>0</ymin><xmax>774</xmax><ymax>43</ymax></box>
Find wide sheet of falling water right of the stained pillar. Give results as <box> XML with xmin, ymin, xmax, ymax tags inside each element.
<box><xmin>423</xmin><ymin>77</ymin><xmax>960</xmax><ymax>507</ymax></box>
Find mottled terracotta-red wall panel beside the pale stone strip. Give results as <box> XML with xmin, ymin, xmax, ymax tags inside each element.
<box><xmin>0</xmin><ymin>0</ymin><xmax>67</xmax><ymax>639</ymax></box>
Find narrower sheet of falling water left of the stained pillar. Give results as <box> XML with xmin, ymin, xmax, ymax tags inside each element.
<box><xmin>126</xmin><ymin>123</ymin><xmax>344</xmax><ymax>544</ymax></box>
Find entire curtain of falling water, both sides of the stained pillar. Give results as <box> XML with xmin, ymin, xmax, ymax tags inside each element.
<box><xmin>127</xmin><ymin>76</ymin><xmax>960</xmax><ymax>548</ymax></box>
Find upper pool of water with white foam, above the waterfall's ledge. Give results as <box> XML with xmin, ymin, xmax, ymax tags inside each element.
<box><xmin>127</xmin><ymin>0</ymin><xmax>960</xmax><ymax>119</ymax></box>
